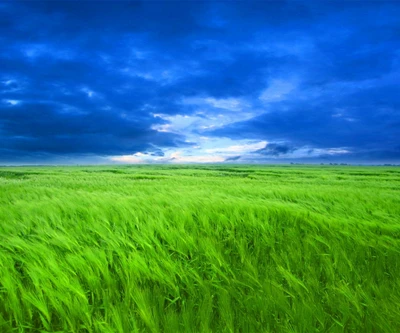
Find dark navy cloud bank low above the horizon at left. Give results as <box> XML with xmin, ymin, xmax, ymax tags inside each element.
<box><xmin>0</xmin><ymin>103</ymin><xmax>181</xmax><ymax>161</ymax></box>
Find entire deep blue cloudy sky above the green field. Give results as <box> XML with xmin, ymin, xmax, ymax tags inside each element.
<box><xmin>0</xmin><ymin>0</ymin><xmax>400</xmax><ymax>164</ymax></box>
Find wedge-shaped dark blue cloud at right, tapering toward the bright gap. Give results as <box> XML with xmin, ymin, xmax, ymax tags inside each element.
<box><xmin>212</xmin><ymin>80</ymin><xmax>400</xmax><ymax>156</ymax></box>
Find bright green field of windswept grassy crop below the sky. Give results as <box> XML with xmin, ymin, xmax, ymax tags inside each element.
<box><xmin>0</xmin><ymin>165</ymin><xmax>400</xmax><ymax>333</ymax></box>
